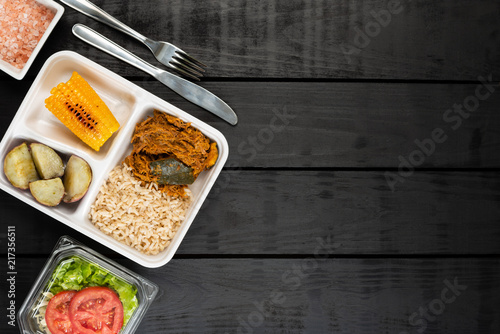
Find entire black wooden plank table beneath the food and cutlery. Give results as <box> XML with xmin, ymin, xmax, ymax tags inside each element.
<box><xmin>0</xmin><ymin>0</ymin><xmax>500</xmax><ymax>334</ymax></box>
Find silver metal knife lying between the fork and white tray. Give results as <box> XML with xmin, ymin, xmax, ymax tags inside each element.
<box><xmin>73</xmin><ymin>23</ymin><xmax>238</xmax><ymax>125</ymax></box>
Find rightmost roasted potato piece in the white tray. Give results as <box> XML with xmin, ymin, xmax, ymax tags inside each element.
<box><xmin>63</xmin><ymin>155</ymin><xmax>92</xmax><ymax>203</ymax></box>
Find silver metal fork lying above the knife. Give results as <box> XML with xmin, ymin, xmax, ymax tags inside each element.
<box><xmin>61</xmin><ymin>0</ymin><xmax>206</xmax><ymax>80</ymax></box>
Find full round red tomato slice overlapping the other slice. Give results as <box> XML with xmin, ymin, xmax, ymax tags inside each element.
<box><xmin>69</xmin><ymin>287</ymin><xmax>123</xmax><ymax>334</ymax></box>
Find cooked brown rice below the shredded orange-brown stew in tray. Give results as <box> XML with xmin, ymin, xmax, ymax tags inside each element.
<box><xmin>89</xmin><ymin>164</ymin><xmax>192</xmax><ymax>255</ymax></box>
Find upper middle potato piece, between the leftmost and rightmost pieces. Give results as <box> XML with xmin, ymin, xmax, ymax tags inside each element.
<box><xmin>30</xmin><ymin>143</ymin><xmax>64</xmax><ymax>180</ymax></box>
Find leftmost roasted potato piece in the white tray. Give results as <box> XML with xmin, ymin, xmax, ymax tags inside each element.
<box><xmin>3</xmin><ymin>143</ymin><xmax>39</xmax><ymax>189</ymax></box>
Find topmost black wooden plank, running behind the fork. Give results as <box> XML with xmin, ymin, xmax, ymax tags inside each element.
<box><xmin>2</xmin><ymin>0</ymin><xmax>500</xmax><ymax>80</ymax></box>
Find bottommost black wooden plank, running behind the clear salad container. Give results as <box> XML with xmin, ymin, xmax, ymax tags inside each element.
<box><xmin>0</xmin><ymin>257</ymin><xmax>500</xmax><ymax>334</ymax></box>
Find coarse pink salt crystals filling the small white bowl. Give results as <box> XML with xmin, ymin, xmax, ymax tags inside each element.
<box><xmin>0</xmin><ymin>0</ymin><xmax>55</xmax><ymax>69</ymax></box>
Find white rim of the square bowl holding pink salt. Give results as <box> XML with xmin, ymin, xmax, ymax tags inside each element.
<box><xmin>0</xmin><ymin>0</ymin><xmax>64</xmax><ymax>80</ymax></box>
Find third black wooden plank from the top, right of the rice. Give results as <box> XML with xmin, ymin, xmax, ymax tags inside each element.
<box><xmin>0</xmin><ymin>170</ymin><xmax>500</xmax><ymax>257</ymax></box>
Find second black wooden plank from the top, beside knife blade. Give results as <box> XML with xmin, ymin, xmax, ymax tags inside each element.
<box><xmin>0</xmin><ymin>80</ymin><xmax>500</xmax><ymax>168</ymax></box>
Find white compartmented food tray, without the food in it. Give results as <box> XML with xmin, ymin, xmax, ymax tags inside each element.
<box><xmin>0</xmin><ymin>51</ymin><xmax>229</xmax><ymax>267</ymax></box>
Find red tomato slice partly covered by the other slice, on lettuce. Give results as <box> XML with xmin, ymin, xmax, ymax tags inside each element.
<box><xmin>45</xmin><ymin>291</ymin><xmax>78</xmax><ymax>334</ymax></box>
